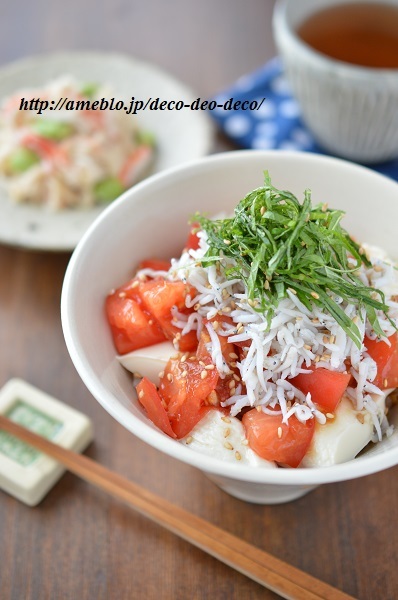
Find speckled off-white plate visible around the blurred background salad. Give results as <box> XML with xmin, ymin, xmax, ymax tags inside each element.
<box><xmin>0</xmin><ymin>52</ymin><xmax>213</xmax><ymax>251</ymax></box>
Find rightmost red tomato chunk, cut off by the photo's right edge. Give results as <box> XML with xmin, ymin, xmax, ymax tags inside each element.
<box><xmin>365</xmin><ymin>333</ymin><xmax>398</xmax><ymax>389</ymax></box>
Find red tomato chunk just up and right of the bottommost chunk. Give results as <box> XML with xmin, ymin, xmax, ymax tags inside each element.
<box><xmin>289</xmin><ymin>367</ymin><xmax>351</xmax><ymax>412</ymax></box>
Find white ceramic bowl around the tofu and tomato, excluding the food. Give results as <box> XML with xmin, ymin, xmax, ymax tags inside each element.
<box><xmin>61</xmin><ymin>151</ymin><xmax>398</xmax><ymax>503</ymax></box>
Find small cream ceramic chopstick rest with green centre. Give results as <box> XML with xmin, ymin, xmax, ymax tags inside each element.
<box><xmin>0</xmin><ymin>379</ymin><xmax>94</xmax><ymax>506</ymax></box>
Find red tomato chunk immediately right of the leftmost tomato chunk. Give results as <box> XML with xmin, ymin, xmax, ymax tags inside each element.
<box><xmin>139</xmin><ymin>279</ymin><xmax>198</xmax><ymax>352</ymax></box>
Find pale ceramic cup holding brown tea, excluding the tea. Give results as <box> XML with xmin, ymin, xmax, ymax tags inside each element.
<box><xmin>273</xmin><ymin>0</ymin><xmax>398</xmax><ymax>163</ymax></box>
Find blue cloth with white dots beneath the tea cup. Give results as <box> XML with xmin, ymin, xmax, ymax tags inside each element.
<box><xmin>210</xmin><ymin>58</ymin><xmax>398</xmax><ymax>181</ymax></box>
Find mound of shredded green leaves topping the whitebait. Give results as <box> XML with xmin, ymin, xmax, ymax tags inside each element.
<box><xmin>194</xmin><ymin>172</ymin><xmax>396</xmax><ymax>348</ymax></box>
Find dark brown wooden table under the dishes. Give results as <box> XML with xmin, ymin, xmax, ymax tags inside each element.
<box><xmin>0</xmin><ymin>0</ymin><xmax>398</xmax><ymax>600</ymax></box>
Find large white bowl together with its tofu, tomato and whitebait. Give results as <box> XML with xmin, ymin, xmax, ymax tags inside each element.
<box><xmin>61</xmin><ymin>151</ymin><xmax>398</xmax><ymax>504</ymax></box>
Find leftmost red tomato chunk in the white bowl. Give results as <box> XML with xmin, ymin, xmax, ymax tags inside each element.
<box><xmin>105</xmin><ymin>280</ymin><xmax>166</xmax><ymax>354</ymax></box>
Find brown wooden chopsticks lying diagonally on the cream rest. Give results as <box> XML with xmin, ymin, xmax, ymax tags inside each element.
<box><xmin>0</xmin><ymin>415</ymin><xmax>353</xmax><ymax>600</ymax></box>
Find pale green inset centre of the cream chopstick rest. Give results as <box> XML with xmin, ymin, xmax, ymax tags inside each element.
<box><xmin>0</xmin><ymin>400</ymin><xmax>62</xmax><ymax>467</ymax></box>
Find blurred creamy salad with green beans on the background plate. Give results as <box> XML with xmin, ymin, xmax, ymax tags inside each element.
<box><xmin>0</xmin><ymin>76</ymin><xmax>155</xmax><ymax>210</ymax></box>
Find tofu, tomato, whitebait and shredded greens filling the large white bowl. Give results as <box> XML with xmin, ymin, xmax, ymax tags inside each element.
<box><xmin>105</xmin><ymin>173</ymin><xmax>398</xmax><ymax>468</ymax></box>
